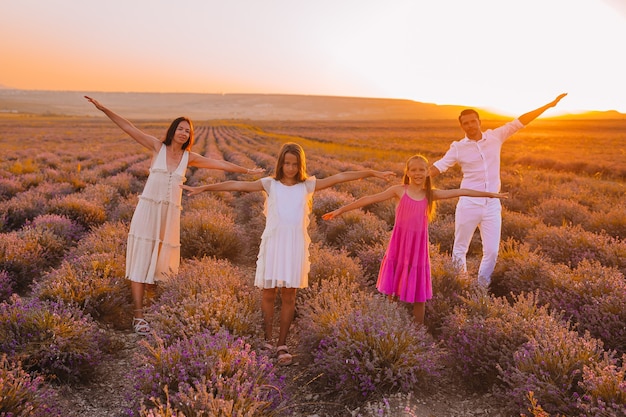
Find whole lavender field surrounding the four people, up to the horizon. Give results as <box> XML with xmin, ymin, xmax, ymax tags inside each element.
<box><xmin>0</xmin><ymin>115</ymin><xmax>626</xmax><ymax>416</ymax></box>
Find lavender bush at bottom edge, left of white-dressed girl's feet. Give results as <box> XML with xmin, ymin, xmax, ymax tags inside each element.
<box><xmin>135</xmin><ymin>331</ymin><xmax>284</xmax><ymax>416</ymax></box>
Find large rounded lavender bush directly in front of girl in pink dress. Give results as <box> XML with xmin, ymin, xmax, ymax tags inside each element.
<box><xmin>312</xmin><ymin>296</ymin><xmax>442</xmax><ymax>400</ymax></box>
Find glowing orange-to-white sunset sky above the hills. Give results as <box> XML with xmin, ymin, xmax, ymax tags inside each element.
<box><xmin>0</xmin><ymin>0</ymin><xmax>626</xmax><ymax>115</ymax></box>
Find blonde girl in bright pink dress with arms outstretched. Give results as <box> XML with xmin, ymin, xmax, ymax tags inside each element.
<box><xmin>322</xmin><ymin>155</ymin><xmax>508</xmax><ymax>324</ymax></box>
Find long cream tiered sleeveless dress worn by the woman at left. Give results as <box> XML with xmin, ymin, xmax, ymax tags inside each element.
<box><xmin>126</xmin><ymin>145</ymin><xmax>189</xmax><ymax>284</ymax></box>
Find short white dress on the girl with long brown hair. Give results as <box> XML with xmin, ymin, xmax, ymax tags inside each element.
<box><xmin>254</xmin><ymin>177</ymin><xmax>316</xmax><ymax>288</ymax></box>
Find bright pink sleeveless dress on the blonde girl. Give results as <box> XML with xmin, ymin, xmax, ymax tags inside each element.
<box><xmin>376</xmin><ymin>187</ymin><xmax>433</xmax><ymax>303</ymax></box>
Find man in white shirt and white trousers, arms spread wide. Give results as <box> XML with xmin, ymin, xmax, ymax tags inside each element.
<box><xmin>430</xmin><ymin>93</ymin><xmax>567</xmax><ymax>287</ymax></box>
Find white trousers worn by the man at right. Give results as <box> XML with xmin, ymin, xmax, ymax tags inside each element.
<box><xmin>452</xmin><ymin>198</ymin><xmax>502</xmax><ymax>284</ymax></box>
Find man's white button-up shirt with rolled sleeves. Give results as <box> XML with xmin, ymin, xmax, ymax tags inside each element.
<box><xmin>433</xmin><ymin>119</ymin><xmax>524</xmax><ymax>203</ymax></box>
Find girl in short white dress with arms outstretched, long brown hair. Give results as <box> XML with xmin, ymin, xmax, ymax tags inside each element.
<box><xmin>181</xmin><ymin>142</ymin><xmax>395</xmax><ymax>365</ymax></box>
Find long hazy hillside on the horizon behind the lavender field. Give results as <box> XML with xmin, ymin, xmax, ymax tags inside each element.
<box><xmin>0</xmin><ymin>89</ymin><xmax>626</xmax><ymax>120</ymax></box>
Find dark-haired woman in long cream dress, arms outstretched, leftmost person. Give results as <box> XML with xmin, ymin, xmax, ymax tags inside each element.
<box><xmin>85</xmin><ymin>96</ymin><xmax>263</xmax><ymax>335</ymax></box>
